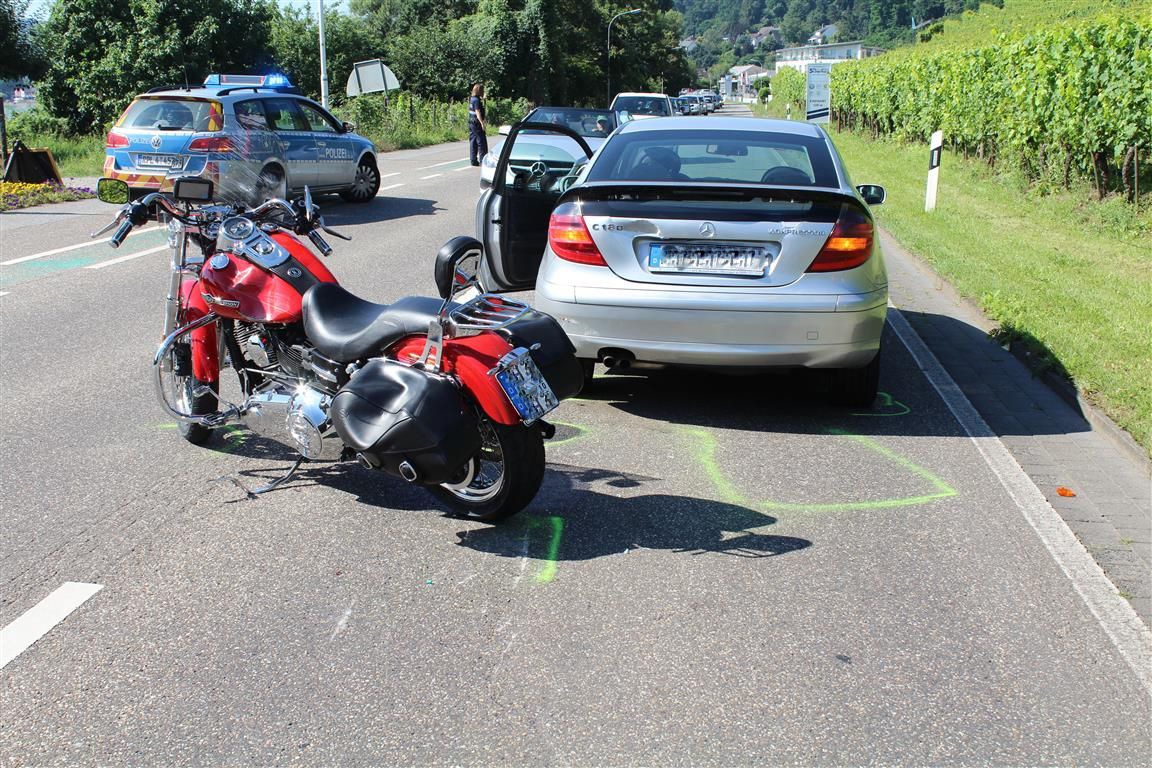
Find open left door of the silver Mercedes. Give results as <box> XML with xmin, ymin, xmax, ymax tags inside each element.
<box><xmin>476</xmin><ymin>122</ymin><xmax>592</xmax><ymax>290</ymax></box>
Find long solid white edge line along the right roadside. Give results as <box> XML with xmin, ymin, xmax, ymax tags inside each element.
<box><xmin>888</xmin><ymin>307</ymin><xmax>1152</xmax><ymax>693</ymax></box>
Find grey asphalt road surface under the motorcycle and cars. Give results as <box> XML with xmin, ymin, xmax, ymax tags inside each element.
<box><xmin>0</xmin><ymin>123</ymin><xmax>1152</xmax><ymax>766</ymax></box>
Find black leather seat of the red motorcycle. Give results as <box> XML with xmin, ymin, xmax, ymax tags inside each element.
<box><xmin>302</xmin><ymin>283</ymin><xmax>442</xmax><ymax>363</ymax></box>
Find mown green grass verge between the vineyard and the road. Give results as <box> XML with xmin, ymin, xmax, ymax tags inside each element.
<box><xmin>833</xmin><ymin>126</ymin><xmax>1152</xmax><ymax>454</ymax></box>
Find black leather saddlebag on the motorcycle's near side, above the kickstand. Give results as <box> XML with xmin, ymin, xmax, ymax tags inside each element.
<box><xmin>331</xmin><ymin>359</ymin><xmax>480</xmax><ymax>485</ymax></box>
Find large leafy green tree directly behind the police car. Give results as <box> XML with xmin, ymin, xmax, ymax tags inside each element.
<box><xmin>40</xmin><ymin>0</ymin><xmax>275</xmax><ymax>134</ymax></box>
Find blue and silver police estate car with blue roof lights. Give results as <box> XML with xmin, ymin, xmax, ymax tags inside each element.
<box><xmin>104</xmin><ymin>75</ymin><xmax>380</xmax><ymax>204</ymax></box>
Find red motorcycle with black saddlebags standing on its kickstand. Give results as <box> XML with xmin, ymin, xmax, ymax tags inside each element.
<box><xmin>93</xmin><ymin>178</ymin><xmax>584</xmax><ymax>522</ymax></box>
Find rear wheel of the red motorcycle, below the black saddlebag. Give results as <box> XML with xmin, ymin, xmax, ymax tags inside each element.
<box><xmin>430</xmin><ymin>418</ymin><xmax>544</xmax><ymax>523</ymax></box>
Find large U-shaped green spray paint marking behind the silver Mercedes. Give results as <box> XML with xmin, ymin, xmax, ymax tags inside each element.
<box><xmin>683</xmin><ymin>428</ymin><xmax>956</xmax><ymax>512</ymax></box>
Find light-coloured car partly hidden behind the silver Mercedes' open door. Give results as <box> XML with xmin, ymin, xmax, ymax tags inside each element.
<box><xmin>480</xmin><ymin>107</ymin><xmax>619</xmax><ymax>187</ymax></box>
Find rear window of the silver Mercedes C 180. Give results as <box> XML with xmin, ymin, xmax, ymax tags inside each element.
<box><xmin>588</xmin><ymin>129</ymin><xmax>840</xmax><ymax>188</ymax></box>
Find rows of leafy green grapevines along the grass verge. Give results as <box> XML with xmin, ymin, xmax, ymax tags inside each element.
<box><xmin>829</xmin><ymin>17</ymin><xmax>1152</xmax><ymax>200</ymax></box>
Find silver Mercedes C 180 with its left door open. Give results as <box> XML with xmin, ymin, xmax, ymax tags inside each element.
<box><xmin>476</xmin><ymin>116</ymin><xmax>888</xmax><ymax>405</ymax></box>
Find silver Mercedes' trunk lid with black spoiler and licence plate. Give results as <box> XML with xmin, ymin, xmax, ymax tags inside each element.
<box><xmin>564</xmin><ymin>183</ymin><xmax>858</xmax><ymax>289</ymax></box>
